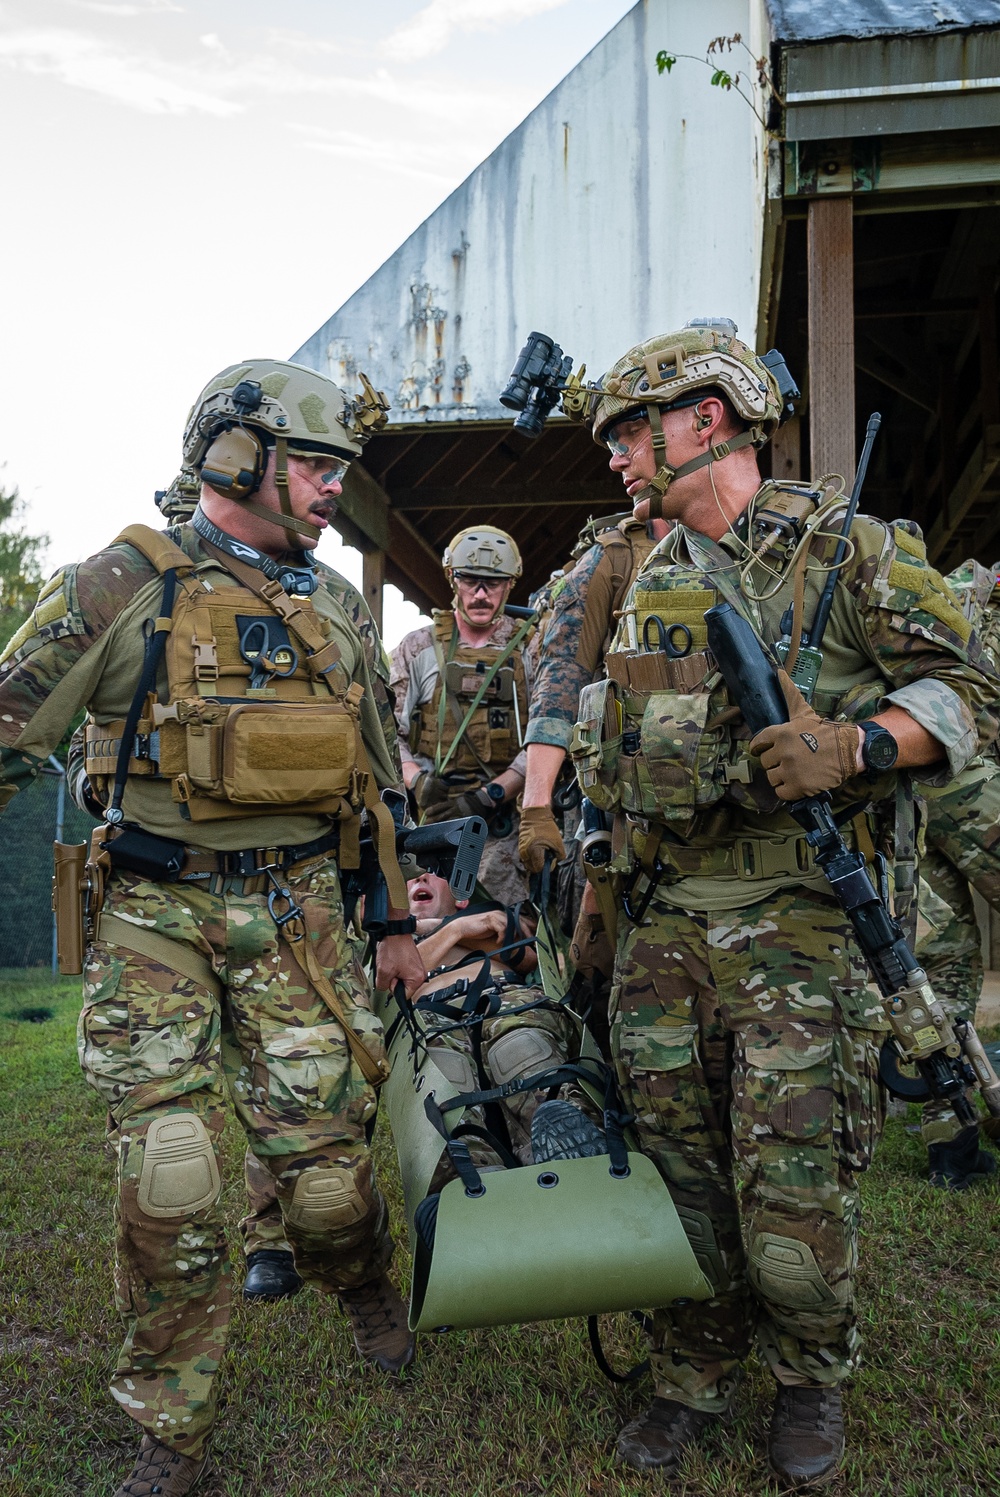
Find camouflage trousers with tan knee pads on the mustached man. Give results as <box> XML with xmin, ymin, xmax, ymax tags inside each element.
<box><xmin>79</xmin><ymin>862</ymin><xmax>392</xmax><ymax>1457</ymax></box>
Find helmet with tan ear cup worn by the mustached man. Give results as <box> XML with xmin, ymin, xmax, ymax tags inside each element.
<box><xmin>184</xmin><ymin>359</ymin><xmax>389</xmax><ymax>548</ymax></box>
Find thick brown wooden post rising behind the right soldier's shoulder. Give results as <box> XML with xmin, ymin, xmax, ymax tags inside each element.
<box><xmin>807</xmin><ymin>198</ymin><xmax>856</xmax><ymax>488</ymax></box>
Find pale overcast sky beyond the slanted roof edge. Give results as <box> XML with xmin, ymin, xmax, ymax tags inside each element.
<box><xmin>0</xmin><ymin>0</ymin><xmax>633</xmax><ymax>644</ymax></box>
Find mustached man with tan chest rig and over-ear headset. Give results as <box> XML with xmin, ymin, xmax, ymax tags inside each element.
<box><xmin>0</xmin><ymin>361</ymin><xmax>424</xmax><ymax>1497</ymax></box>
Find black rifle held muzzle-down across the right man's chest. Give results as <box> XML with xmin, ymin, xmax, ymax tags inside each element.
<box><xmin>705</xmin><ymin>603</ymin><xmax>1000</xmax><ymax>1132</ymax></box>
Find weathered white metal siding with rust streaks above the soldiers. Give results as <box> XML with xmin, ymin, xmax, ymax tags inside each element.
<box><xmin>293</xmin><ymin>0</ymin><xmax>765</xmax><ymax>425</ymax></box>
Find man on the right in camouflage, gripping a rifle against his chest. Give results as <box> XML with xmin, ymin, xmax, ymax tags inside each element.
<box><xmin>547</xmin><ymin>320</ymin><xmax>996</xmax><ymax>1487</ymax></box>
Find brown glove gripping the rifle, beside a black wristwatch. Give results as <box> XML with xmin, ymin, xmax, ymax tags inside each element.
<box><xmin>750</xmin><ymin>671</ymin><xmax>861</xmax><ymax>801</ymax></box>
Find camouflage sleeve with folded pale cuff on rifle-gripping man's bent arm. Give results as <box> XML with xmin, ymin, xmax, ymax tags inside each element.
<box><xmin>844</xmin><ymin>516</ymin><xmax>1000</xmax><ymax>775</ymax></box>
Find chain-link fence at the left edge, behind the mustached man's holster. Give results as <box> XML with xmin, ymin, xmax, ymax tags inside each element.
<box><xmin>0</xmin><ymin>757</ymin><xmax>96</xmax><ymax>967</ymax></box>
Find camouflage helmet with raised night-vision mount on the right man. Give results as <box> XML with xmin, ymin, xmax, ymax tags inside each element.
<box><xmin>563</xmin><ymin>317</ymin><xmax>783</xmax><ymax>519</ymax></box>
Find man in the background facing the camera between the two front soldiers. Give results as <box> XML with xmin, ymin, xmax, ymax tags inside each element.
<box><xmin>391</xmin><ymin>525</ymin><xmax>533</xmax><ymax>904</ymax></box>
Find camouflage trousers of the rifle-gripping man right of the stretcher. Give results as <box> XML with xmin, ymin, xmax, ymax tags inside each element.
<box><xmin>612</xmin><ymin>889</ymin><xmax>883</xmax><ymax>1413</ymax></box>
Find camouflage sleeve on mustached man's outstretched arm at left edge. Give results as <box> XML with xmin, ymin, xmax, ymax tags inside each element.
<box><xmin>0</xmin><ymin>546</ymin><xmax>156</xmax><ymax>807</ymax></box>
